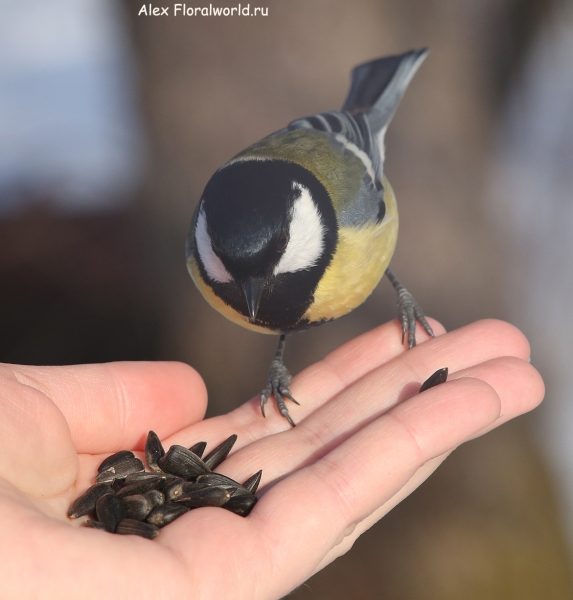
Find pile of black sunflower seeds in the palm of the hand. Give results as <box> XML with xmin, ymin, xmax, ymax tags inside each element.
<box><xmin>68</xmin><ymin>431</ymin><xmax>262</xmax><ymax>539</ymax></box>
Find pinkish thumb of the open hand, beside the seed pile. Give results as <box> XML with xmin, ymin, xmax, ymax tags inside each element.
<box><xmin>9</xmin><ymin>362</ymin><xmax>207</xmax><ymax>454</ymax></box>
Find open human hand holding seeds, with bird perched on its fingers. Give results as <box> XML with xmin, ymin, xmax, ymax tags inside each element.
<box><xmin>0</xmin><ymin>321</ymin><xmax>543</xmax><ymax>600</ymax></box>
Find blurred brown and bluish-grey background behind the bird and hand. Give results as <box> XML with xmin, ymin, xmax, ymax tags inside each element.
<box><xmin>0</xmin><ymin>0</ymin><xmax>573</xmax><ymax>600</ymax></box>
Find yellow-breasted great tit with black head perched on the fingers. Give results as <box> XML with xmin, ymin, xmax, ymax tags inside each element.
<box><xmin>186</xmin><ymin>50</ymin><xmax>434</xmax><ymax>426</ymax></box>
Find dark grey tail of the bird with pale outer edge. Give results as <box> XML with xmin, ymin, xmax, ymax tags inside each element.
<box><xmin>342</xmin><ymin>48</ymin><xmax>428</xmax><ymax>132</ymax></box>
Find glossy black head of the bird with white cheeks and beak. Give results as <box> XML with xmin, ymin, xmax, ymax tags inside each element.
<box><xmin>190</xmin><ymin>159</ymin><xmax>337</xmax><ymax>331</ymax></box>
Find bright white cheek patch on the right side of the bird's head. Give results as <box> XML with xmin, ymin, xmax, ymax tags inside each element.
<box><xmin>274</xmin><ymin>183</ymin><xmax>324</xmax><ymax>275</ymax></box>
